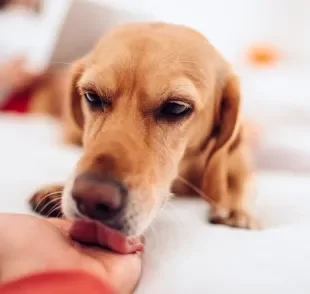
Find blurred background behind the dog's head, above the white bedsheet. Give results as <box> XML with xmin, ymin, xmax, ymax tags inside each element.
<box><xmin>0</xmin><ymin>0</ymin><xmax>310</xmax><ymax>173</ymax></box>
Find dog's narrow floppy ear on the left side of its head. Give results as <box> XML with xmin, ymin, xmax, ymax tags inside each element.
<box><xmin>63</xmin><ymin>61</ymin><xmax>84</xmax><ymax>144</ymax></box>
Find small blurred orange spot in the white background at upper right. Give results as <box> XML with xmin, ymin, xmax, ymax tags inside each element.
<box><xmin>247</xmin><ymin>44</ymin><xmax>280</xmax><ymax>65</ymax></box>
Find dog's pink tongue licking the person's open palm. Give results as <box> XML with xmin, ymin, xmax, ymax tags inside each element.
<box><xmin>70</xmin><ymin>220</ymin><xmax>144</xmax><ymax>254</ymax></box>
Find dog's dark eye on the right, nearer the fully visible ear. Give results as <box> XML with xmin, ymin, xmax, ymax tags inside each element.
<box><xmin>159</xmin><ymin>101</ymin><xmax>192</xmax><ymax>119</ymax></box>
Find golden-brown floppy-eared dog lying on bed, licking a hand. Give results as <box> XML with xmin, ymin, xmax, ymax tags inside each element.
<box><xmin>31</xmin><ymin>23</ymin><xmax>257</xmax><ymax>235</ymax></box>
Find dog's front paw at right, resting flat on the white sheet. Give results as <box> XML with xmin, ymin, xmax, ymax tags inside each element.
<box><xmin>209</xmin><ymin>207</ymin><xmax>260</xmax><ymax>230</ymax></box>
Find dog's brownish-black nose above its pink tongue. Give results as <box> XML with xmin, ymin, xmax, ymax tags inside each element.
<box><xmin>72</xmin><ymin>173</ymin><xmax>128</xmax><ymax>222</ymax></box>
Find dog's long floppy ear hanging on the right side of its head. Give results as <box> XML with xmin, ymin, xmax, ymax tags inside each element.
<box><xmin>202</xmin><ymin>75</ymin><xmax>242</xmax><ymax>201</ymax></box>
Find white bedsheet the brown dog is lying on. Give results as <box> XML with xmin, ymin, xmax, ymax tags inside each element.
<box><xmin>0</xmin><ymin>116</ymin><xmax>310</xmax><ymax>294</ymax></box>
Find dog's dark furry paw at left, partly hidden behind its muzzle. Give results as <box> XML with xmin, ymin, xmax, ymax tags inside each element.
<box><xmin>29</xmin><ymin>185</ymin><xmax>64</xmax><ymax>217</ymax></box>
